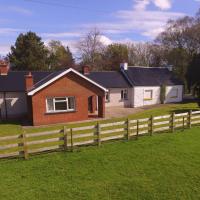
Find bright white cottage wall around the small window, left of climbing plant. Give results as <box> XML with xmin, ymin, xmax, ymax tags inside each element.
<box><xmin>132</xmin><ymin>86</ymin><xmax>160</xmax><ymax>107</ymax></box>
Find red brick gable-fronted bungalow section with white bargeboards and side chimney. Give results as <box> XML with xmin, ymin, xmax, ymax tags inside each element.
<box><xmin>26</xmin><ymin>68</ymin><xmax>107</xmax><ymax>125</ymax></box>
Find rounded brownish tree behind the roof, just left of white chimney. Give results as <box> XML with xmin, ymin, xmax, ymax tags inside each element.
<box><xmin>103</xmin><ymin>43</ymin><xmax>128</xmax><ymax>70</ymax></box>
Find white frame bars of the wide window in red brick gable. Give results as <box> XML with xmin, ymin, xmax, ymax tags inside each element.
<box><xmin>46</xmin><ymin>96</ymin><xmax>76</xmax><ymax>113</ymax></box>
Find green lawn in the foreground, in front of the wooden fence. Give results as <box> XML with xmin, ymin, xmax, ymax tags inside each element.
<box><xmin>0</xmin><ymin>127</ymin><xmax>200</xmax><ymax>200</ymax></box>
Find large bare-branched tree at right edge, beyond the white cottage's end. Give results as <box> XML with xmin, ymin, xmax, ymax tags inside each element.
<box><xmin>155</xmin><ymin>14</ymin><xmax>200</xmax><ymax>90</ymax></box>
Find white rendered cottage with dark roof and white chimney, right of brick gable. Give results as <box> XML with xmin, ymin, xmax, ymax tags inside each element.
<box><xmin>87</xmin><ymin>63</ymin><xmax>183</xmax><ymax>107</ymax></box>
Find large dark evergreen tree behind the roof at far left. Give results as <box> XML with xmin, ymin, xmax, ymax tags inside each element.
<box><xmin>8</xmin><ymin>32</ymin><xmax>48</xmax><ymax>70</ymax></box>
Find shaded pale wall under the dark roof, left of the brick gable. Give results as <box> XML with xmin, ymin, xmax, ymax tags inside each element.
<box><xmin>0</xmin><ymin>92</ymin><xmax>27</xmax><ymax>118</ymax></box>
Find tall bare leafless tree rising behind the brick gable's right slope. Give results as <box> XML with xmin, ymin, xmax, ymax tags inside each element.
<box><xmin>77</xmin><ymin>28</ymin><xmax>105</xmax><ymax>70</ymax></box>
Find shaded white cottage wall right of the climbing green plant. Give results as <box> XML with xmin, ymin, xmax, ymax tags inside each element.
<box><xmin>165</xmin><ymin>85</ymin><xmax>183</xmax><ymax>103</ymax></box>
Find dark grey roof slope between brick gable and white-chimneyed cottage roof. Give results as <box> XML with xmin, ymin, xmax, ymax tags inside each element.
<box><xmin>86</xmin><ymin>71</ymin><xmax>131</xmax><ymax>88</ymax></box>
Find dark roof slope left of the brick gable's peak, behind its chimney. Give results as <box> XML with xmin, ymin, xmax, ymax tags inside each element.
<box><xmin>0</xmin><ymin>71</ymin><xmax>52</xmax><ymax>92</ymax></box>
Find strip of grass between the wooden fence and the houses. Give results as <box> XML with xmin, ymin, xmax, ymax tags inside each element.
<box><xmin>0</xmin><ymin>103</ymin><xmax>199</xmax><ymax>136</ymax></box>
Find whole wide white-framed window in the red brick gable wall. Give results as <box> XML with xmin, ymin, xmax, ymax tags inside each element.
<box><xmin>46</xmin><ymin>97</ymin><xmax>75</xmax><ymax>113</ymax></box>
